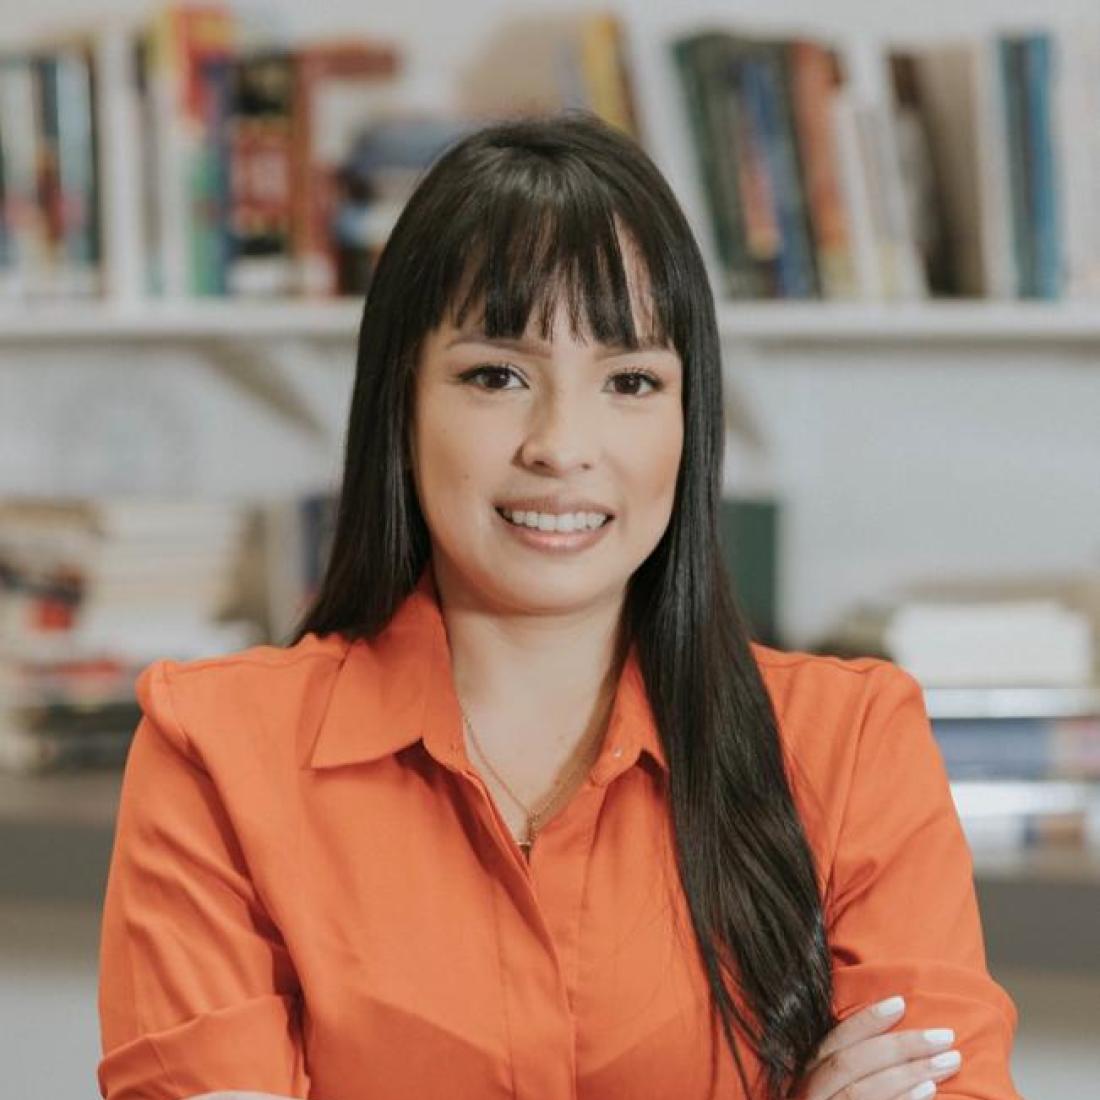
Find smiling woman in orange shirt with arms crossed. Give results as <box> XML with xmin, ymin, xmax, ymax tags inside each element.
<box><xmin>99</xmin><ymin>112</ymin><xmax>1018</xmax><ymax>1100</ymax></box>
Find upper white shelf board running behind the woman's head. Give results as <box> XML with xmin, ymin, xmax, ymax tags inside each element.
<box><xmin>0</xmin><ymin>297</ymin><xmax>1100</xmax><ymax>345</ymax></box>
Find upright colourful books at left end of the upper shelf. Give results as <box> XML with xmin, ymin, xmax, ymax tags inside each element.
<box><xmin>0</xmin><ymin>2</ymin><xmax>409</xmax><ymax>299</ymax></box>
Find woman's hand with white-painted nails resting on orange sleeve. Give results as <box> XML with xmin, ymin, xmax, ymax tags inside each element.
<box><xmin>793</xmin><ymin>1005</ymin><xmax>961</xmax><ymax>1100</ymax></box>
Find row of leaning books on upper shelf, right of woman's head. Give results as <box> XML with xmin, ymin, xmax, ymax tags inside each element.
<box><xmin>671</xmin><ymin>26</ymin><xmax>1100</xmax><ymax>303</ymax></box>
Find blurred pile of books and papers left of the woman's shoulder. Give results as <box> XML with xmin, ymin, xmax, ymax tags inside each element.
<box><xmin>0</xmin><ymin>497</ymin><xmax>260</xmax><ymax>772</ymax></box>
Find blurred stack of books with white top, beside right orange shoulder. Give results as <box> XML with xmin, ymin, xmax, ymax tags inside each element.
<box><xmin>814</xmin><ymin>574</ymin><xmax>1100</xmax><ymax>853</ymax></box>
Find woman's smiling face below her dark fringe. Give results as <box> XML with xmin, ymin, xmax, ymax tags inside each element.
<box><xmin>410</xmin><ymin>268</ymin><xmax>683</xmax><ymax>613</ymax></box>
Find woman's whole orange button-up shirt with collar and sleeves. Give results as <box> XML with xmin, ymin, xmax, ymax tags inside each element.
<box><xmin>98</xmin><ymin>568</ymin><xmax>1019</xmax><ymax>1100</ymax></box>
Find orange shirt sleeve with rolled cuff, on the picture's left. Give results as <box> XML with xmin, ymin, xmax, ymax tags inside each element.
<box><xmin>97</xmin><ymin>661</ymin><xmax>309</xmax><ymax>1100</ymax></box>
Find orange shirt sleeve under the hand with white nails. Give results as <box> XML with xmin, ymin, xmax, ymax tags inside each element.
<box><xmin>826</xmin><ymin>662</ymin><xmax>1020</xmax><ymax>1100</ymax></box>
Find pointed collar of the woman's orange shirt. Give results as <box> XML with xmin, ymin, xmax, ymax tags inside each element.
<box><xmin>309</xmin><ymin>561</ymin><xmax>668</xmax><ymax>785</ymax></box>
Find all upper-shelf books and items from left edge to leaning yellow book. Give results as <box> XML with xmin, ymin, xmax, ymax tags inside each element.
<box><xmin>0</xmin><ymin>0</ymin><xmax>635</xmax><ymax>307</ymax></box>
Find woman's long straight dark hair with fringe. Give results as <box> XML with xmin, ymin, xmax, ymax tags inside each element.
<box><xmin>292</xmin><ymin>110</ymin><xmax>837</xmax><ymax>1098</ymax></box>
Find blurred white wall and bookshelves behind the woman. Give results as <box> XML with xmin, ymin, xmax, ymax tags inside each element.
<box><xmin>0</xmin><ymin>0</ymin><xmax>1100</xmax><ymax>1100</ymax></box>
